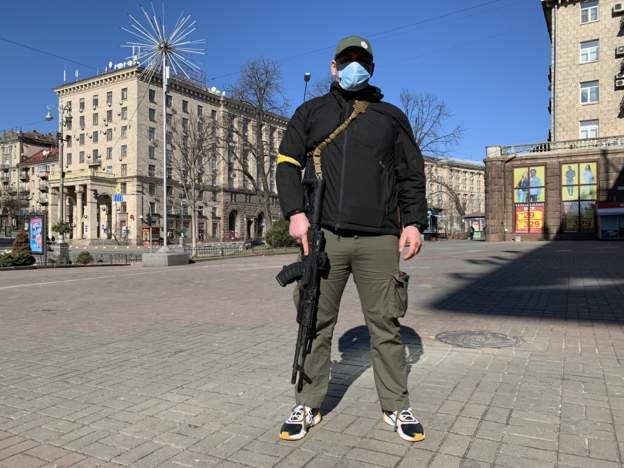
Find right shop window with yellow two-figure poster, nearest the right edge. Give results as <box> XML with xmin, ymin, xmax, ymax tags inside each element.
<box><xmin>561</xmin><ymin>162</ymin><xmax>598</xmax><ymax>233</ymax></box>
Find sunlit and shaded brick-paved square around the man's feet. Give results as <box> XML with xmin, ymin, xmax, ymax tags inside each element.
<box><xmin>0</xmin><ymin>241</ymin><xmax>624</xmax><ymax>468</ymax></box>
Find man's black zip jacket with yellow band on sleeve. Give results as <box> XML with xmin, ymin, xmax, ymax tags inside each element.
<box><xmin>277</xmin><ymin>83</ymin><xmax>427</xmax><ymax>235</ymax></box>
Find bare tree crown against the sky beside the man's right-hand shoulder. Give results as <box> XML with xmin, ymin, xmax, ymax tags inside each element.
<box><xmin>400</xmin><ymin>89</ymin><xmax>464</xmax><ymax>155</ymax></box>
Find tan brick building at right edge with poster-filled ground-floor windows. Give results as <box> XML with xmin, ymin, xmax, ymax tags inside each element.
<box><xmin>486</xmin><ymin>0</ymin><xmax>624</xmax><ymax>240</ymax></box>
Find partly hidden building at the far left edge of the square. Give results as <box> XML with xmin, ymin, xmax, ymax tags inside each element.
<box><xmin>0</xmin><ymin>130</ymin><xmax>56</xmax><ymax>235</ymax></box>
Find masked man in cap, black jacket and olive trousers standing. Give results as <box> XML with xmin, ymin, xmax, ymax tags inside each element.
<box><xmin>277</xmin><ymin>36</ymin><xmax>427</xmax><ymax>441</ymax></box>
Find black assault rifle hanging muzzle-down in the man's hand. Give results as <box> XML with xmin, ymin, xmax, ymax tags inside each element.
<box><xmin>276</xmin><ymin>173</ymin><xmax>329</xmax><ymax>391</ymax></box>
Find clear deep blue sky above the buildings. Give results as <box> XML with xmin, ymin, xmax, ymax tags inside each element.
<box><xmin>0</xmin><ymin>0</ymin><xmax>550</xmax><ymax>160</ymax></box>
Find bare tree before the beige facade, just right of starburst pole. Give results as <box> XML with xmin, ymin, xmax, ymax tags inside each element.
<box><xmin>171</xmin><ymin>109</ymin><xmax>217</xmax><ymax>252</ymax></box>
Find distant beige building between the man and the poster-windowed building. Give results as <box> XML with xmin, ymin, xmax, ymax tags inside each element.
<box><xmin>425</xmin><ymin>156</ymin><xmax>485</xmax><ymax>234</ymax></box>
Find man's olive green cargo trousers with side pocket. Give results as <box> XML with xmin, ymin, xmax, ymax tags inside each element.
<box><xmin>294</xmin><ymin>229</ymin><xmax>409</xmax><ymax>411</ymax></box>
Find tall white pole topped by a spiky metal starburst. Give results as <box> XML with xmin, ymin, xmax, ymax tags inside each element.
<box><xmin>122</xmin><ymin>4</ymin><xmax>204</xmax><ymax>250</ymax></box>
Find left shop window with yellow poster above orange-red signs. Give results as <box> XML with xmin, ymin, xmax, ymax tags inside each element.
<box><xmin>513</xmin><ymin>166</ymin><xmax>546</xmax><ymax>234</ymax></box>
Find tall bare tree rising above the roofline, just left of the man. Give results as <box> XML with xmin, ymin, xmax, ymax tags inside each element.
<box><xmin>226</xmin><ymin>58</ymin><xmax>288</xmax><ymax>226</ymax></box>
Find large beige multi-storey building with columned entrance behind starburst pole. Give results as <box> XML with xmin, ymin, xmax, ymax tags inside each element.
<box><xmin>49</xmin><ymin>64</ymin><xmax>287</xmax><ymax>245</ymax></box>
